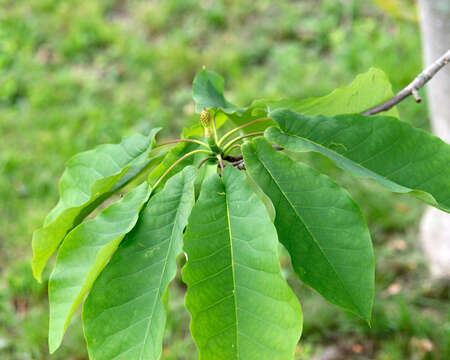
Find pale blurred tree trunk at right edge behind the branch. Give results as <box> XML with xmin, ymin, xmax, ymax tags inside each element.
<box><xmin>419</xmin><ymin>0</ymin><xmax>450</xmax><ymax>279</ymax></box>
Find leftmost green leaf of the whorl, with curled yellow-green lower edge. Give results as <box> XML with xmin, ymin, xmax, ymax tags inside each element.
<box><xmin>32</xmin><ymin>129</ymin><xmax>160</xmax><ymax>281</ymax></box>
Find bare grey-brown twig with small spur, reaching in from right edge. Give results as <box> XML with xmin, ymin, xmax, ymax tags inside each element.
<box><xmin>362</xmin><ymin>49</ymin><xmax>450</xmax><ymax>115</ymax></box>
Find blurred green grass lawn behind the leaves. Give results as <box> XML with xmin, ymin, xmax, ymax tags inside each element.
<box><xmin>0</xmin><ymin>0</ymin><xmax>450</xmax><ymax>360</ymax></box>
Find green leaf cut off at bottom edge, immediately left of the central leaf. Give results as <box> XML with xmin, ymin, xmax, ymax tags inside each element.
<box><xmin>83</xmin><ymin>167</ymin><xmax>196</xmax><ymax>360</ymax></box>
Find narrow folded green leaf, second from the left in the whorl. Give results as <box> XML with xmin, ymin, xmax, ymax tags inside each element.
<box><xmin>48</xmin><ymin>182</ymin><xmax>150</xmax><ymax>353</ymax></box>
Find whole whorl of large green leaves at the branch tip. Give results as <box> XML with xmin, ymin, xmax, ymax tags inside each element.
<box><xmin>33</xmin><ymin>69</ymin><xmax>450</xmax><ymax>360</ymax></box>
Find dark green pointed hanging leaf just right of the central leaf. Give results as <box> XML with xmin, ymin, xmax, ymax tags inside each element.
<box><xmin>242</xmin><ymin>138</ymin><xmax>375</xmax><ymax>322</ymax></box>
